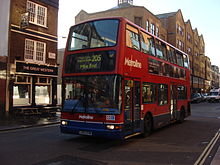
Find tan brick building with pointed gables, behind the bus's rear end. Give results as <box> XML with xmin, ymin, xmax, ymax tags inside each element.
<box><xmin>157</xmin><ymin>10</ymin><xmax>211</xmax><ymax>92</ymax></box>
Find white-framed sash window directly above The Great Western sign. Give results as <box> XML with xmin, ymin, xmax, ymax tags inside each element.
<box><xmin>24</xmin><ymin>39</ymin><xmax>46</xmax><ymax>63</ymax></box>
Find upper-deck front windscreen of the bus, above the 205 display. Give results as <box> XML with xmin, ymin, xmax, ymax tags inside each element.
<box><xmin>68</xmin><ymin>19</ymin><xmax>119</xmax><ymax>51</ymax></box>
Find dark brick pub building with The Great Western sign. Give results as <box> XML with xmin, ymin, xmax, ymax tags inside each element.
<box><xmin>0</xmin><ymin>0</ymin><xmax>59</xmax><ymax>117</ymax></box>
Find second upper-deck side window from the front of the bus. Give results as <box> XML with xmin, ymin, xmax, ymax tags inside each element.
<box><xmin>141</xmin><ymin>32</ymin><xmax>155</xmax><ymax>56</ymax></box>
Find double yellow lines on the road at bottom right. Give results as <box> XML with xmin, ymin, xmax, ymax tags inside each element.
<box><xmin>194</xmin><ymin>129</ymin><xmax>220</xmax><ymax>165</ymax></box>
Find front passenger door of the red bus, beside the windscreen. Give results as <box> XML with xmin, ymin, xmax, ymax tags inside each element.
<box><xmin>124</xmin><ymin>79</ymin><xmax>141</xmax><ymax>135</ymax></box>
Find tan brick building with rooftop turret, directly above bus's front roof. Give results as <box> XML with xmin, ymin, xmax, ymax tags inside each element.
<box><xmin>75</xmin><ymin>0</ymin><xmax>167</xmax><ymax>40</ymax></box>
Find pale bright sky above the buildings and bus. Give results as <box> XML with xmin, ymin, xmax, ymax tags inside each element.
<box><xmin>58</xmin><ymin>0</ymin><xmax>220</xmax><ymax>67</ymax></box>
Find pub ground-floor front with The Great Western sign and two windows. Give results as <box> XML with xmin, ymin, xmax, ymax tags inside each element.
<box><xmin>10</xmin><ymin>61</ymin><xmax>59</xmax><ymax>114</ymax></box>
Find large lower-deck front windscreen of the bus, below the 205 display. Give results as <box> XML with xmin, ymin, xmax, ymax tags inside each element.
<box><xmin>62</xmin><ymin>75</ymin><xmax>121</xmax><ymax>114</ymax></box>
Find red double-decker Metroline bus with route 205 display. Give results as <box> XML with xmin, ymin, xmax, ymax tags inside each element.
<box><xmin>60</xmin><ymin>17</ymin><xmax>190</xmax><ymax>139</ymax></box>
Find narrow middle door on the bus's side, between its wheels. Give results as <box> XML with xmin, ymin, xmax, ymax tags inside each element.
<box><xmin>170</xmin><ymin>84</ymin><xmax>177</xmax><ymax>120</ymax></box>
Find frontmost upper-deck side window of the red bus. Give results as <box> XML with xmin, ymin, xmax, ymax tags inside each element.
<box><xmin>126</xmin><ymin>25</ymin><xmax>140</xmax><ymax>50</ymax></box>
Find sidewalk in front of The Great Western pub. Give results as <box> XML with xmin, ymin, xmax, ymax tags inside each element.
<box><xmin>0</xmin><ymin>112</ymin><xmax>60</xmax><ymax>132</ymax></box>
